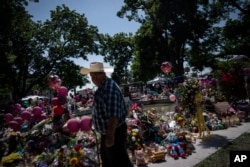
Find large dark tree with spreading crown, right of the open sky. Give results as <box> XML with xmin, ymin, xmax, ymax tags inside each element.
<box><xmin>117</xmin><ymin>0</ymin><xmax>227</xmax><ymax>81</ymax></box>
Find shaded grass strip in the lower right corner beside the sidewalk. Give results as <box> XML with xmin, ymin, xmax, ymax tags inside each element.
<box><xmin>194</xmin><ymin>132</ymin><xmax>250</xmax><ymax>167</ymax></box>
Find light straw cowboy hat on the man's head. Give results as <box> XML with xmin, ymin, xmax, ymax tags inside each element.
<box><xmin>80</xmin><ymin>62</ymin><xmax>113</xmax><ymax>75</ymax></box>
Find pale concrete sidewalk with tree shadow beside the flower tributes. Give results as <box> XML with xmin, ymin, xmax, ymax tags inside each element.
<box><xmin>148</xmin><ymin>122</ymin><xmax>250</xmax><ymax>167</ymax></box>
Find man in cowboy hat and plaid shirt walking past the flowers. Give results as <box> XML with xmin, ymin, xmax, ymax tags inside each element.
<box><xmin>80</xmin><ymin>62</ymin><xmax>133</xmax><ymax>167</ymax></box>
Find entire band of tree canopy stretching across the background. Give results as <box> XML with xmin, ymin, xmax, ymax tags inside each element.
<box><xmin>0</xmin><ymin>0</ymin><xmax>250</xmax><ymax>98</ymax></box>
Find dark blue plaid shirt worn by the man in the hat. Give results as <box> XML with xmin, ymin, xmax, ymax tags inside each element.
<box><xmin>92</xmin><ymin>78</ymin><xmax>128</xmax><ymax>133</ymax></box>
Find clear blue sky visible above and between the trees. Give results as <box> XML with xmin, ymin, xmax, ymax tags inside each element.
<box><xmin>26</xmin><ymin>0</ymin><xmax>139</xmax><ymax>87</ymax></box>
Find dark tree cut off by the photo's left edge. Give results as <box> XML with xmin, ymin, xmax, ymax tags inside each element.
<box><xmin>0</xmin><ymin>0</ymin><xmax>32</xmax><ymax>99</ymax></box>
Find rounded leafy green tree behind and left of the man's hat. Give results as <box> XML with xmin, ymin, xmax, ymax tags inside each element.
<box><xmin>36</xmin><ymin>5</ymin><xmax>99</xmax><ymax>91</ymax></box>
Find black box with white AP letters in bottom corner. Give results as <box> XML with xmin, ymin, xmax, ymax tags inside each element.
<box><xmin>230</xmin><ymin>151</ymin><xmax>250</xmax><ymax>167</ymax></box>
